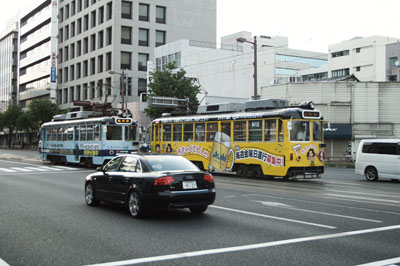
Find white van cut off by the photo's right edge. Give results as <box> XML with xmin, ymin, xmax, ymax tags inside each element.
<box><xmin>355</xmin><ymin>139</ymin><xmax>400</xmax><ymax>181</ymax></box>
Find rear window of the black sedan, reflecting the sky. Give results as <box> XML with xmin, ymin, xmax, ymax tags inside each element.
<box><xmin>146</xmin><ymin>156</ymin><xmax>199</xmax><ymax>171</ymax></box>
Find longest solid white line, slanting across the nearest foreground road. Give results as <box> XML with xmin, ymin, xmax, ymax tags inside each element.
<box><xmin>84</xmin><ymin>225</ymin><xmax>400</xmax><ymax>266</ymax></box>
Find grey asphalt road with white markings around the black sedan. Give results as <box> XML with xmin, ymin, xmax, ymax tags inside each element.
<box><xmin>0</xmin><ymin>156</ymin><xmax>400</xmax><ymax>266</ymax></box>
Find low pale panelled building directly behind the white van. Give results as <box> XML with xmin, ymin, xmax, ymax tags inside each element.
<box><xmin>261</xmin><ymin>82</ymin><xmax>400</xmax><ymax>159</ymax></box>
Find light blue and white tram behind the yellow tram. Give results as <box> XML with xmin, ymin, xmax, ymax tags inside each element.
<box><xmin>40</xmin><ymin>113</ymin><xmax>139</xmax><ymax>166</ymax></box>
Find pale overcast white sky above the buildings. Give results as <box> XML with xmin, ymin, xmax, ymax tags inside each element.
<box><xmin>0</xmin><ymin>0</ymin><xmax>400</xmax><ymax>53</ymax></box>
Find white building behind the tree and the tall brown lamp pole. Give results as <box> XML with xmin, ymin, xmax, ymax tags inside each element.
<box><xmin>155</xmin><ymin>32</ymin><xmax>328</xmax><ymax>99</ymax></box>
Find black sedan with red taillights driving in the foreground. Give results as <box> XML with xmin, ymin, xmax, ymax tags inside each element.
<box><xmin>85</xmin><ymin>154</ymin><xmax>215</xmax><ymax>218</ymax></box>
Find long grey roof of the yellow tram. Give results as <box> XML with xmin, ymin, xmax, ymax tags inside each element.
<box><xmin>152</xmin><ymin>107</ymin><xmax>322</xmax><ymax>124</ymax></box>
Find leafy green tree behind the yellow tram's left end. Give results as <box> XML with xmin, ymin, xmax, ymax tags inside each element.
<box><xmin>144</xmin><ymin>62</ymin><xmax>200</xmax><ymax>119</ymax></box>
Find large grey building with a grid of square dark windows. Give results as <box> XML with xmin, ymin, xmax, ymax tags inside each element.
<box><xmin>57</xmin><ymin>0</ymin><xmax>216</xmax><ymax>124</ymax></box>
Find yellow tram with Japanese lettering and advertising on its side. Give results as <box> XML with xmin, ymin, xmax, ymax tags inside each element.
<box><xmin>151</xmin><ymin>102</ymin><xmax>325</xmax><ymax>178</ymax></box>
